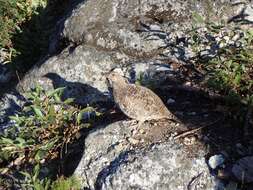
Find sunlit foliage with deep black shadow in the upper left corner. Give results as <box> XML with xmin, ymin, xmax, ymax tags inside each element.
<box><xmin>0</xmin><ymin>0</ymin><xmax>70</xmax><ymax>77</ymax></box>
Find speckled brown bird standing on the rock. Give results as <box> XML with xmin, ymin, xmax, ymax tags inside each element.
<box><xmin>106</xmin><ymin>70</ymin><xmax>174</xmax><ymax>125</ymax></box>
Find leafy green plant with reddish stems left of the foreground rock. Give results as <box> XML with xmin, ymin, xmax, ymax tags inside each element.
<box><xmin>0</xmin><ymin>86</ymin><xmax>99</xmax><ymax>190</ymax></box>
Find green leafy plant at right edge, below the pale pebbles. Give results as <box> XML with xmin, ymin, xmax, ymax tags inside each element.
<box><xmin>207</xmin><ymin>30</ymin><xmax>253</xmax><ymax>104</ymax></box>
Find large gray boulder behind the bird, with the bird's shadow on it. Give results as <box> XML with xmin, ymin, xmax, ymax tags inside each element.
<box><xmin>18</xmin><ymin>0</ymin><xmax>252</xmax><ymax>104</ymax></box>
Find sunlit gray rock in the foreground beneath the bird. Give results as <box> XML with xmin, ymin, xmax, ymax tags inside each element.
<box><xmin>75</xmin><ymin>121</ymin><xmax>222</xmax><ymax>190</ymax></box>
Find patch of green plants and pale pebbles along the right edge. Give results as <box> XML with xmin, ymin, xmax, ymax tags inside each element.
<box><xmin>189</xmin><ymin>13</ymin><xmax>253</xmax><ymax>122</ymax></box>
